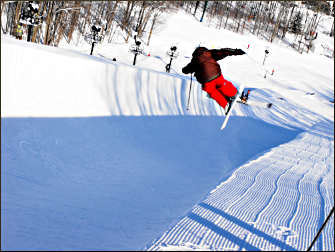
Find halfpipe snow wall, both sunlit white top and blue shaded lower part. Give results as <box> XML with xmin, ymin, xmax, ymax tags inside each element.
<box><xmin>1</xmin><ymin>35</ymin><xmax>299</xmax><ymax>250</ymax></box>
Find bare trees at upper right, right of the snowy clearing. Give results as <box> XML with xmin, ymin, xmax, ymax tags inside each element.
<box><xmin>185</xmin><ymin>0</ymin><xmax>334</xmax><ymax>53</ymax></box>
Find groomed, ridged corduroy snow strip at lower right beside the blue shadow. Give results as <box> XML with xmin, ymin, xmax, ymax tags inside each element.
<box><xmin>148</xmin><ymin>121</ymin><xmax>334</xmax><ymax>251</ymax></box>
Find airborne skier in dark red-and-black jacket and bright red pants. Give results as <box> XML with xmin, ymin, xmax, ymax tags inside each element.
<box><xmin>182</xmin><ymin>47</ymin><xmax>245</xmax><ymax>113</ymax></box>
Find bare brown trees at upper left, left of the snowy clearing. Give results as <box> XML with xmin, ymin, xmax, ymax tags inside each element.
<box><xmin>1</xmin><ymin>0</ymin><xmax>180</xmax><ymax>46</ymax></box>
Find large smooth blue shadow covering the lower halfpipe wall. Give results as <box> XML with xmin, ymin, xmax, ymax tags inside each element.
<box><xmin>1</xmin><ymin>116</ymin><xmax>300</xmax><ymax>250</ymax></box>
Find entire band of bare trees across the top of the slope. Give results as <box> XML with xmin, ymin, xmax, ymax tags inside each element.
<box><xmin>1</xmin><ymin>0</ymin><xmax>334</xmax><ymax>52</ymax></box>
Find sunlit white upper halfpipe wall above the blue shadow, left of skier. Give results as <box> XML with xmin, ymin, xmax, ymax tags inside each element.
<box><xmin>1</xmin><ymin>35</ymin><xmax>226</xmax><ymax>117</ymax></box>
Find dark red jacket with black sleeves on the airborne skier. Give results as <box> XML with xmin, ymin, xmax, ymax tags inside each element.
<box><xmin>182</xmin><ymin>47</ymin><xmax>244</xmax><ymax>84</ymax></box>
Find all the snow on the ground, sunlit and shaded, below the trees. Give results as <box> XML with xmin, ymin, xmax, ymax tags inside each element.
<box><xmin>1</xmin><ymin>7</ymin><xmax>334</xmax><ymax>251</ymax></box>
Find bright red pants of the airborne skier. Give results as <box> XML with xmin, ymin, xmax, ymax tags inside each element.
<box><xmin>202</xmin><ymin>74</ymin><xmax>237</xmax><ymax>108</ymax></box>
